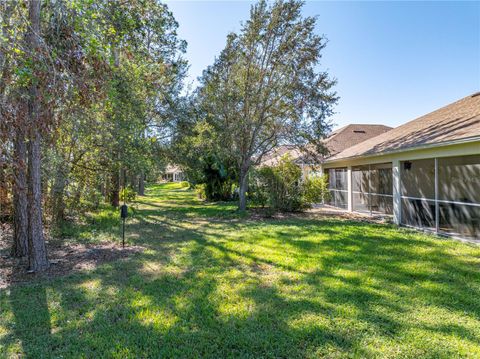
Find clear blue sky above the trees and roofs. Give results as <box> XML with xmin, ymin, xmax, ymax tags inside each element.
<box><xmin>166</xmin><ymin>0</ymin><xmax>480</xmax><ymax>127</ymax></box>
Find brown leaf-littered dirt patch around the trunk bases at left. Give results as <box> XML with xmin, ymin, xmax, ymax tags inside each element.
<box><xmin>0</xmin><ymin>224</ymin><xmax>144</xmax><ymax>289</ymax></box>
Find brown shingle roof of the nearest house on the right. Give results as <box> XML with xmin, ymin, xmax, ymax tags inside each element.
<box><xmin>328</xmin><ymin>92</ymin><xmax>480</xmax><ymax>162</ymax></box>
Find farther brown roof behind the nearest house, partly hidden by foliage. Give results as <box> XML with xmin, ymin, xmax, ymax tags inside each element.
<box><xmin>261</xmin><ymin>124</ymin><xmax>392</xmax><ymax>166</ymax></box>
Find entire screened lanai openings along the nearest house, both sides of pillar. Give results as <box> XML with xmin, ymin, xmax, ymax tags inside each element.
<box><xmin>325</xmin><ymin>155</ymin><xmax>480</xmax><ymax>240</ymax></box>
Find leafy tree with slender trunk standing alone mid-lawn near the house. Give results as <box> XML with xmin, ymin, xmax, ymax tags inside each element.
<box><xmin>198</xmin><ymin>0</ymin><xmax>337</xmax><ymax>210</ymax></box>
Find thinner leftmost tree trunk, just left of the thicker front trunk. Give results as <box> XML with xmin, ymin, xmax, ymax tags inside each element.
<box><xmin>12</xmin><ymin>128</ymin><xmax>28</xmax><ymax>257</ymax></box>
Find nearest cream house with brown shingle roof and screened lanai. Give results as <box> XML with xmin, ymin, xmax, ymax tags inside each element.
<box><xmin>322</xmin><ymin>92</ymin><xmax>480</xmax><ymax>240</ymax></box>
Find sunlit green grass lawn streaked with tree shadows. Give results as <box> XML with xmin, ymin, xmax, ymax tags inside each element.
<box><xmin>0</xmin><ymin>184</ymin><xmax>480</xmax><ymax>358</ymax></box>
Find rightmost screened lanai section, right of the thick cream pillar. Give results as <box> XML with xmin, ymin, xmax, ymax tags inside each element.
<box><xmin>400</xmin><ymin>155</ymin><xmax>480</xmax><ymax>239</ymax></box>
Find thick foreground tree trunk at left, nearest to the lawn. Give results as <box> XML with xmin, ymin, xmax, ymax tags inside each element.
<box><xmin>28</xmin><ymin>0</ymin><xmax>48</xmax><ymax>272</ymax></box>
